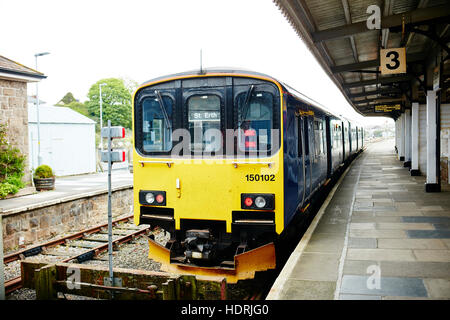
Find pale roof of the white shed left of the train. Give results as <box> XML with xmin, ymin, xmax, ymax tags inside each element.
<box><xmin>28</xmin><ymin>106</ymin><xmax>95</xmax><ymax>124</ymax></box>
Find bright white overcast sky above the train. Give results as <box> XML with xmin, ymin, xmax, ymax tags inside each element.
<box><xmin>0</xmin><ymin>0</ymin><xmax>387</xmax><ymax>124</ymax></box>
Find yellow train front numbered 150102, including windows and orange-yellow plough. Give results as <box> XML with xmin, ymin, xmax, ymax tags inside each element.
<box><xmin>133</xmin><ymin>71</ymin><xmax>284</xmax><ymax>282</ymax></box>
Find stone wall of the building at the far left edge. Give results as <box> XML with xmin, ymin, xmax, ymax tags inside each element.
<box><xmin>0</xmin><ymin>79</ymin><xmax>31</xmax><ymax>183</ymax></box>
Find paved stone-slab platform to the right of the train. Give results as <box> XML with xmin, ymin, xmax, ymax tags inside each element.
<box><xmin>267</xmin><ymin>140</ymin><xmax>450</xmax><ymax>300</ymax></box>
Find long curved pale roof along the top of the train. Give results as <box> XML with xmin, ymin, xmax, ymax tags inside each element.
<box><xmin>141</xmin><ymin>67</ymin><xmax>353</xmax><ymax>122</ymax></box>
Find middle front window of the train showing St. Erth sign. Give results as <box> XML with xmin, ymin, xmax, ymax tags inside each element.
<box><xmin>187</xmin><ymin>94</ymin><xmax>223</xmax><ymax>152</ymax></box>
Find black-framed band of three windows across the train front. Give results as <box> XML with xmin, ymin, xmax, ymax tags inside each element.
<box><xmin>134</xmin><ymin>77</ymin><xmax>281</xmax><ymax>157</ymax></box>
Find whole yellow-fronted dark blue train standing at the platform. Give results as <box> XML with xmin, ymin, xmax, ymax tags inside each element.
<box><xmin>132</xmin><ymin>68</ymin><xmax>364</xmax><ymax>283</ymax></box>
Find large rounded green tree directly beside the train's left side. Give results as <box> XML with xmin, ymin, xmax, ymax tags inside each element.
<box><xmin>86</xmin><ymin>78</ymin><xmax>131</xmax><ymax>129</ymax></box>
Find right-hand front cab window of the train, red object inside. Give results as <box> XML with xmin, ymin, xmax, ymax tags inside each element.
<box><xmin>233</xmin><ymin>84</ymin><xmax>280</xmax><ymax>155</ymax></box>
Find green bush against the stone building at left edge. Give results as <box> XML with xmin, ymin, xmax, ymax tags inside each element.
<box><xmin>0</xmin><ymin>124</ymin><xmax>26</xmax><ymax>199</ymax></box>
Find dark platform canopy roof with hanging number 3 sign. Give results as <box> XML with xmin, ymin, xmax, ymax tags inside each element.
<box><xmin>273</xmin><ymin>0</ymin><xmax>450</xmax><ymax>119</ymax></box>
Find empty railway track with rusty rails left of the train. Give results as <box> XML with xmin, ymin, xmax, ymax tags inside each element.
<box><xmin>4</xmin><ymin>216</ymin><xmax>150</xmax><ymax>294</ymax></box>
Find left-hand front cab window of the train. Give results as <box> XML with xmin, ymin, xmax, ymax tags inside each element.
<box><xmin>142</xmin><ymin>95</ymin><xmax>173</xmax><ymax>152</ymax></box>
